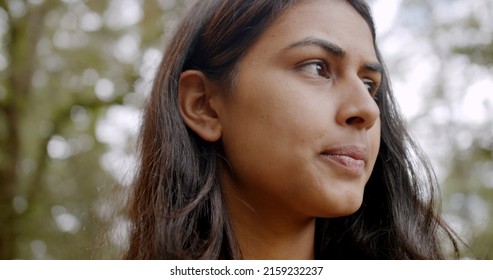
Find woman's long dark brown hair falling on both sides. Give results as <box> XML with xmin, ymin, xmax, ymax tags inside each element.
<box><xmin>125</xmin><ymin>0</ymin><xmax>458</xmax><ymax>259</ymax></box>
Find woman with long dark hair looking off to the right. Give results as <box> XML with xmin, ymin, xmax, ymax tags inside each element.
<box><xmin>126</xmin><ymin>0</ymin><xmax>457</xmax><ymax>259</ymax></box>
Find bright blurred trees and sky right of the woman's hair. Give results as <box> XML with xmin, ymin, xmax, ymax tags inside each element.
<box><xmin>391</xmin><ymin>0</ymin><xmax>493</xmax><ymax>259</ymax></box>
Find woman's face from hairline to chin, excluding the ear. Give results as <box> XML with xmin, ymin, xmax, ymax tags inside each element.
<box><xmin>217</xmin><ymin>0</ymin><xmax>381</xmax><ymax>218</ymax></box>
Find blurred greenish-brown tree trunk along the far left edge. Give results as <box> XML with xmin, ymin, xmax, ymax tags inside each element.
<box><xmin>0</xmin><ymin>1</ymin><xmax>47</xmax><ymax>259</ymax></box>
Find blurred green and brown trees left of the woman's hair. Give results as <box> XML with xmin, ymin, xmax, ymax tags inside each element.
<box><xmin>0</xmin><ymin>0</ymin><xmax>188</xmax><ymax>259</ymax></box>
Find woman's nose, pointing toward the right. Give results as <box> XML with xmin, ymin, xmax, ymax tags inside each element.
<box><xmin>337</xmin><ymin>78</ymin><xmax>380</xmax><ymax>129</ymax></box>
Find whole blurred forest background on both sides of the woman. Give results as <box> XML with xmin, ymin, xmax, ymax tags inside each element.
<box><xmin>0</xmin><ymin>0</ymin><xmax>493</xmax><ymax>259</ymax></box>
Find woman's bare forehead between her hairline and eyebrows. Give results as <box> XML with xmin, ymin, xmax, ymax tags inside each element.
<box><xmin>246</xmin><ymin>0</ymin><xmax>377</xmax><ymax>61</ymax></box>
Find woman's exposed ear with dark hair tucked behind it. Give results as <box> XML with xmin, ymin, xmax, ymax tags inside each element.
<box><xmin>178</xmin><ymin>70</ymin><xmax>222</xmax><ymax>142</ymax></box>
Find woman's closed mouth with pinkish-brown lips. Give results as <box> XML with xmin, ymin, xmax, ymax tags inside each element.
<box><xmin>321</xmin><ymin>146</ymin><xmax>369</xmax><ymax>175</ymax></box>
